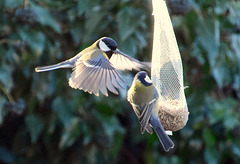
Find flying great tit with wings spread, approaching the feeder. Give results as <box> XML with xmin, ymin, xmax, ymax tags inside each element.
<box><xmin>35</xmin><ymin>37</ymin><xmax>150</xmax><ymax>96</ymax></box>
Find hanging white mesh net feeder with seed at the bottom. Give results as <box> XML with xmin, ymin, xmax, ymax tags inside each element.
<box><xmin>151</xmin><ymin>0</ymin><xmax>189</xmax><ymax>131</ymax></box>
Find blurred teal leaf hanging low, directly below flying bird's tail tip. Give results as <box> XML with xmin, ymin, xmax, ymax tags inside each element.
<box><xmin>25</xmin><ymin>114</ymin><xmax>43</xmax><ymax>143</ymax></box>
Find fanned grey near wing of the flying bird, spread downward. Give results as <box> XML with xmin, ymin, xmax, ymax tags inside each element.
<box><xmin>69</xmin><ymin>56</ymin><xmax>125</xmax><ymax>96</ymax></box>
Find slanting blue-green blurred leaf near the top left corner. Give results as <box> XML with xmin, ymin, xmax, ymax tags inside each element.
<box><xmin>31</xmin><ymin>3</ymin><xmax>61</xmax><ymax>33</ymax></box>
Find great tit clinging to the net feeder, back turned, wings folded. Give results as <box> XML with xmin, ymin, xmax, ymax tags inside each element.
<box><xmin>127</xmin><ymin>71</ymin><xmax>174</xmax><ymax>151</ymax></box>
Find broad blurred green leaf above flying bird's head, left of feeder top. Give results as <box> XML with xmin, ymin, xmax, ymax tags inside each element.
<box><xmin>117</xmin><ymin>7</ymin><xmax>145</xmax><ymax>41</ymax></box>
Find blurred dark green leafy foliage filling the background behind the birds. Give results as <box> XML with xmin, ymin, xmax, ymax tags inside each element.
<box><xmin>0</xmin><ymin>0</ymin><xmax>240</xmax><ymax>164</ymax></box>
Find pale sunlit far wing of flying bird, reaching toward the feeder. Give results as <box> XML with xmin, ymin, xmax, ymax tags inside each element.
<box><xmin>110</xmin><ymin>53</ymin><xmax>151</xmax><ymax>71</ymax></box>
